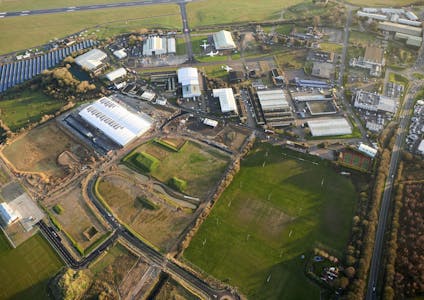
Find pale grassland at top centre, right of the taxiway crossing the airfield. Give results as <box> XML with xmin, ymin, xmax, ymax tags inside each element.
<box><xmin>187</xmin><ymin>0</ymin><xmax>305</xmax><ymax>28</ymax></box>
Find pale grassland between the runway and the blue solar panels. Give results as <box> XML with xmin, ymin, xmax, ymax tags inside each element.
<box><xmin>0</xmin><ymin>5</ymin><xmax>181</xmax><ymax>54</ymax></box>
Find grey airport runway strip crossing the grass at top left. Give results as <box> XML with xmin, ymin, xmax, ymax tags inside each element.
<box><xmin>0</xmin><ymin>0</ymin><xmax>185</xmax><ymax>18</ymax></box>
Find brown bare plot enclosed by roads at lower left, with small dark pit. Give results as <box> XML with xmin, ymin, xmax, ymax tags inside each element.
<box><xmin>43</xmin><ymin>182</ymin><xmax>107</xmax><ymax>249</ymax></box>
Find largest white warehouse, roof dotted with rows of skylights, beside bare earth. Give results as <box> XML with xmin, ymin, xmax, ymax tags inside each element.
<box><xmin>79</xmin><ymin>97</ymin><xmax>152</xmax><ymax>147</ymax></box>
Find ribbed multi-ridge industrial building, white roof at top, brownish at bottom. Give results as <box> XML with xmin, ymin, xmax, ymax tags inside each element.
<box><xmin>257</xmin><ymin>89</ymin><xmax>294</xmax><ymax>127</ymax></box>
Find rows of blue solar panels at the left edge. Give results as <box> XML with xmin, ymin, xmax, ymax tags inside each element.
<box><xmin>0</xmin><ymin>40</ymin><xmax>96</xmax><ymax>93</ymax></box>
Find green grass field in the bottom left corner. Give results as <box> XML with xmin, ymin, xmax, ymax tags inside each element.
<box><xmin>0</xmin><ymin>232</ymin><xmax>62</xmax><ymax>299</ymax></box>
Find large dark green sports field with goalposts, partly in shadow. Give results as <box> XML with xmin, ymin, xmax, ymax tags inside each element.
<box><xmin>184</xmin><ymin>144</ymin><xmax>357</xmax><ymax>299</ymax></box>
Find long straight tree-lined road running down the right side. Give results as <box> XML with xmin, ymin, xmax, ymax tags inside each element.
<box><xmin>366</xmin><ymin>83</ymin><xmax>419</xmax><ymax>300</ymax></box>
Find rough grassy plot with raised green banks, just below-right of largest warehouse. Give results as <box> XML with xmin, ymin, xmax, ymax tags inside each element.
<box><xmin>124</xmin><ymin>141</ymin><xmax>229</xmax><ymax>198</ymax></box>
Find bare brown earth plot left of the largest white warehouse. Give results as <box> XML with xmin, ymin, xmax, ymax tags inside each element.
<box><xmin>2</xmin><ymin>122</ymin><xmax>89</xmax><ymax>178</ymax></box>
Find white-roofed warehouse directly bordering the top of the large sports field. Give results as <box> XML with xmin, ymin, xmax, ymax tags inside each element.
<box><xmin>308</xmin><ymin>118</ymin><xmax>352</xmax><ymax>136</ymax></box>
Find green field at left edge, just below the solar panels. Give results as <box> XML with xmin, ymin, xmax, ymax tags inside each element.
<box><xmin>0</xmin><ymin>91</ymin><xmax>64</xmax><ymax>131</ymax></box>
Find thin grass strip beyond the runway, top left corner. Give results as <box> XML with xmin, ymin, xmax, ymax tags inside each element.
<box><xmin>0</xmin><ymin>0</ymin><xmax>152</xmax><ymax>11</ymax></box>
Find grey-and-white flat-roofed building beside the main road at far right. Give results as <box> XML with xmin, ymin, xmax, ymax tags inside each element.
<box><xmin>353</xmin><ymin>90</ymin><xmax>398</xmax><ymax>114</ymax></box>
